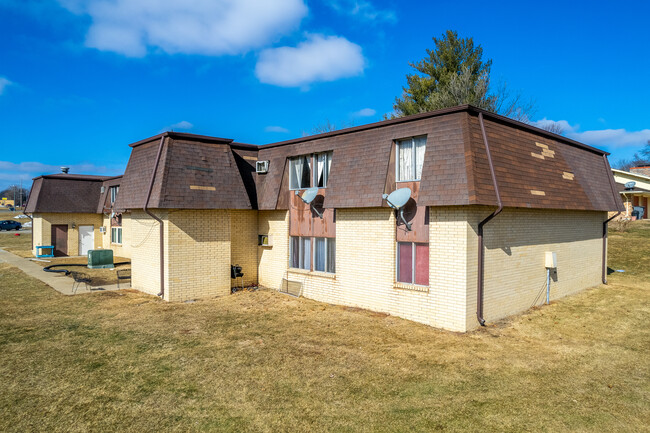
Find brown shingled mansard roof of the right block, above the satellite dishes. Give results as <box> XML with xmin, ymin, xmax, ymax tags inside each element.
<box><xmin>257</xmin><ymin>105</ymin><xmax>622</xmax><ymax>211</ymax></box>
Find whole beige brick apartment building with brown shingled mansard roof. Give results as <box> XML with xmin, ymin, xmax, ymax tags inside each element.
<box><xmin>28</xmin><ymin>106</ymin><xmax>624</xmax><ymax>331</ymax></box>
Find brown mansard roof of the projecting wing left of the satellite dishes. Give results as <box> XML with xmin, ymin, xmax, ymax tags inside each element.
<box><xmin>115</xmin><ymin>132</ymin><xmax>257</xmax><ymax>209</ymax></box>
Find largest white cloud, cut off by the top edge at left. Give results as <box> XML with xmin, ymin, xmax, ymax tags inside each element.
<box><xmin>58</xmin><ymin>0</ymin><xmax>308</xmax><ymax>57</ymax></box>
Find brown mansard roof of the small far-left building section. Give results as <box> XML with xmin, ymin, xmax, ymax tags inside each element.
<box><xmin>25</xmin><ymin>173</ymin><xmax>119</xmax><ymax>213</ymax></box>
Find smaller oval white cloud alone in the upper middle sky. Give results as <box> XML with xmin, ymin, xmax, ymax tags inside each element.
<box><xmin>255</xmin><ymin>35</ymin><xmax>365</xmax><ymax>87</ymax></box>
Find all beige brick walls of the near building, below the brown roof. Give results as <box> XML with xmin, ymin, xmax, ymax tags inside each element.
<box><xmin>125</xmin><ymin>206</ymin><xmax>605</xmax><ymax>331</ymax></box>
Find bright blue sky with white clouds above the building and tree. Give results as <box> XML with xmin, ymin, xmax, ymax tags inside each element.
<box><xmin>0</xmin><ymin>0</ymin><xmax>650</xmax><ymax>189</ymax></box>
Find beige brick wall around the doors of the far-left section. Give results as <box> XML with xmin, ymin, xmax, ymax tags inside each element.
<box><xmin>32</xmin><ymin>213</ymin><xmax>103</xmax><ymax>256</ymax></box>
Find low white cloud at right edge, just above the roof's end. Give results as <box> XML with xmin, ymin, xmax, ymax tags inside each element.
<box><xmin>532</xmin><ymin>118</ymin><xmax>650</xmax><ymax>149</ymax></box>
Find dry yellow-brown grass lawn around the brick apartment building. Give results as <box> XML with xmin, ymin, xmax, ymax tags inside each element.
<box><xmin>0</xmin><ymin>224</ymin><xmax>650</xmax><ymax>432</ymax></box>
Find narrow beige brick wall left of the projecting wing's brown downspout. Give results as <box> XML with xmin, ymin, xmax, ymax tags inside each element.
<box><xmin>126</xmin><ymin>210</ymin><xmax>168</xmax><ymax>295</ymax></box>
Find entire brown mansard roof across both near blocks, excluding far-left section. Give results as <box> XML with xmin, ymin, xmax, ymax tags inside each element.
<box><xmin>68</xmin><ymin>105</ymin><xmax>622</xmax><ymax>211</ymax></box>
